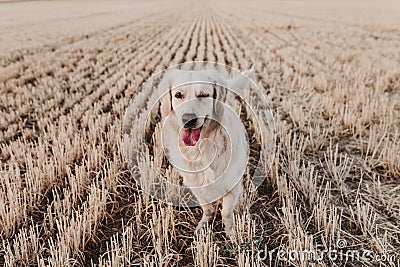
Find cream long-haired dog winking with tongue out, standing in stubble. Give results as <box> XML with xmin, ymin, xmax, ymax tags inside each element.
<box><xmin>158</xmin><ymin>69</ymin><xmax>254</xmax><ymax>236</ymax></box>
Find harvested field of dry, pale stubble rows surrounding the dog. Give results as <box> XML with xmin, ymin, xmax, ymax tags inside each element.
<box><xmin>0</xmin><ymin>0</ymin><xmax>400</xmax><ymax>266</ymax></box>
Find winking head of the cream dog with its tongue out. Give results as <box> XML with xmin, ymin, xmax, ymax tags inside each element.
<box><xmin>159</xmin><ymin>70</ymin><xmax>253</xmax><ymax>146</ymax></box>
